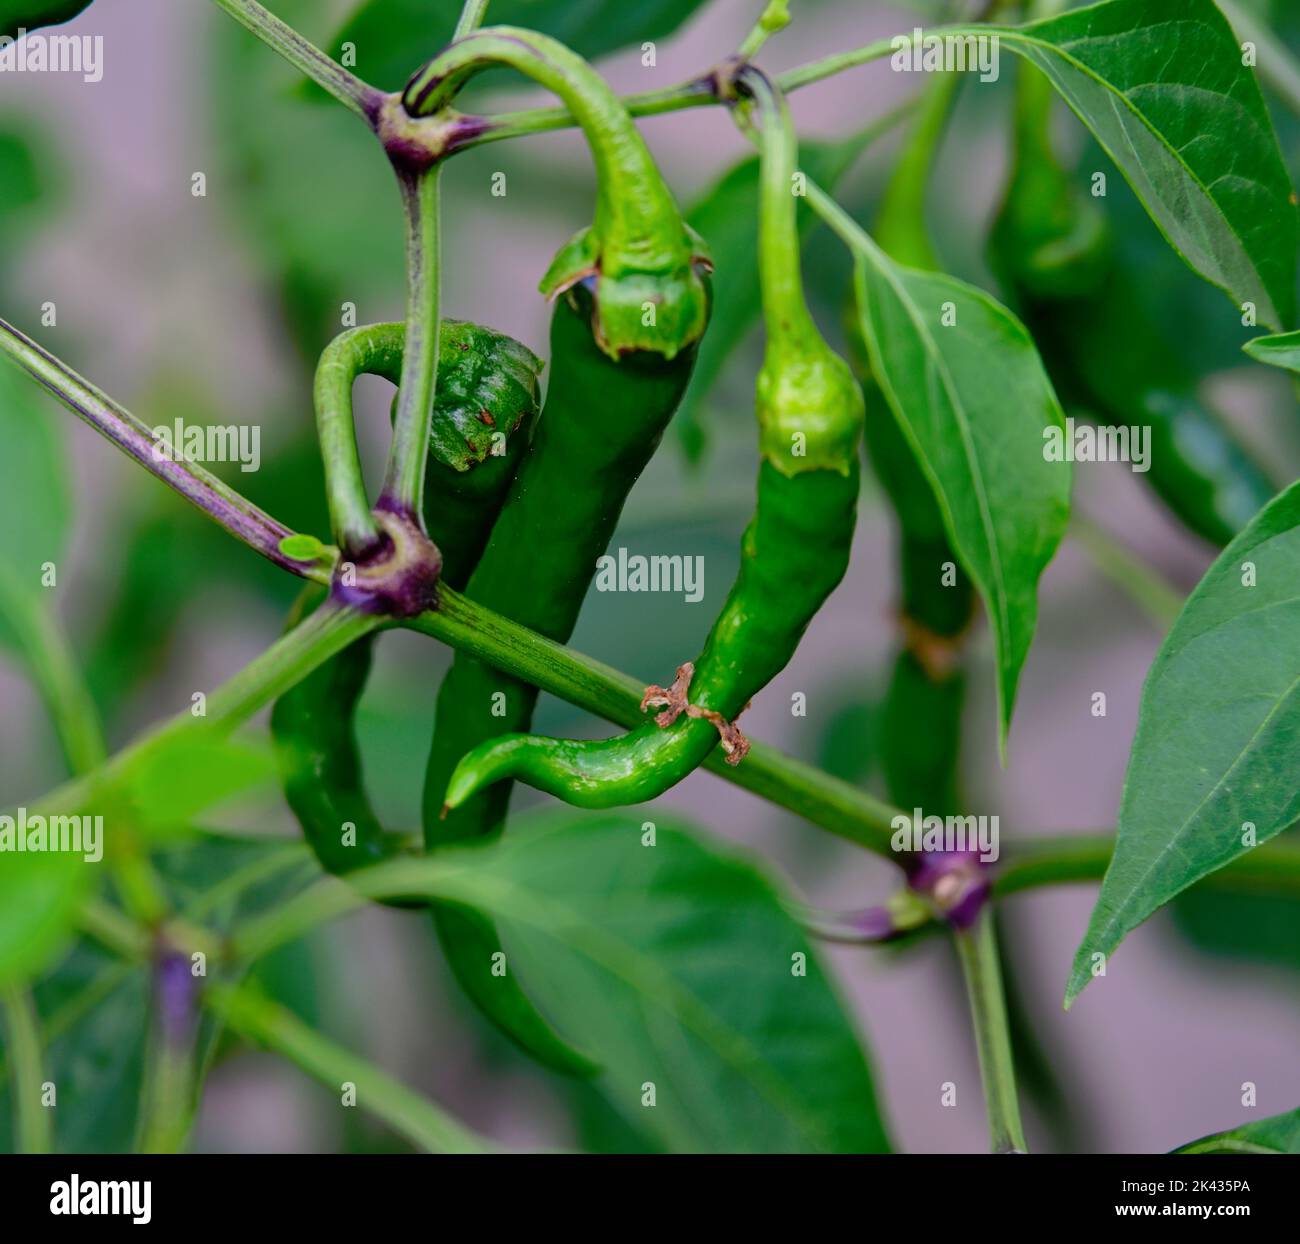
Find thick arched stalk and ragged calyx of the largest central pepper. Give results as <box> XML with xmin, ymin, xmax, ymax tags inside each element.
<box><xmin>402</xmin><ymin>26</ymin><xmax>709</xmax><ymax>359</ymax></box>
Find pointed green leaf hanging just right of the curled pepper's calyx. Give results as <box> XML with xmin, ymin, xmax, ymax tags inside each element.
<box><xmin>855</xmin><ymin>247</ymin><xmax>1070</xmax><ymax>751</ymax></box>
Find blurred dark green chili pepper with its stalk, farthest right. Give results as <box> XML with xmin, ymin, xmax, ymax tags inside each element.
<box><xmin>989</xmin><ymin>65</ymin><xmax>1277</xmax><ymax>545</ymax></box>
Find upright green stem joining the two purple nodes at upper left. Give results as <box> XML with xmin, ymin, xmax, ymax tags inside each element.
<box><xmin>378</xmin><ymin>164</ymin><xmax>441</xmax><ymax>526</ymax></box>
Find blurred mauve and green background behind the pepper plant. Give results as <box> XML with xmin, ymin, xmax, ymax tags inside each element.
<box><xmin>0</xmin><ymin>0</ymin><xmax>1300</xmax><ymax>1152</ymax></box>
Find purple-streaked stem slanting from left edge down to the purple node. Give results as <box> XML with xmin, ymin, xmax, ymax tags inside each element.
<box><xmin>0</xmin><ymin>320</ymin><xmax>328</xmax><ymax>582</ymax></box>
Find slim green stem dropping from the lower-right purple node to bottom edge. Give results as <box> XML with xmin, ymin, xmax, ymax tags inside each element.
<box><xmin>953</xmin><ymin>905</ymin><xmax>1028</xmax><ymax>1153</ymax></box>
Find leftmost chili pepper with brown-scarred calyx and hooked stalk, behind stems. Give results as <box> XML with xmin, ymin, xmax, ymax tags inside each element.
<box><xmin>270</xmin><ymin>320</ymin><xmax>541</xmax><ymax>894</ymax></box>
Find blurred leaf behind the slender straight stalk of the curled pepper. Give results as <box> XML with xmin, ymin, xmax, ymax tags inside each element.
<box><xmin>673</xmin><ymin>117</ymin><xmax>894</xmax><ymax>461</ymax></box>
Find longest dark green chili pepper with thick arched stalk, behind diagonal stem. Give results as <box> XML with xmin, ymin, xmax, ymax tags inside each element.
<box><xmin>403</xmin><ymin>29</ymin><xmax>710</xmax><ymax>1070</ymax></box>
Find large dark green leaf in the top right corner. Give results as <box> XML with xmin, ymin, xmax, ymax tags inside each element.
<box><xmin>1000</xmin><ymin>0</ymin><xmax>1300</xmax><ymax>329</ymax></box>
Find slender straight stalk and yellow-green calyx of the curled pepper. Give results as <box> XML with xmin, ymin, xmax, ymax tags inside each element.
<box><xmin>737</xmin><ymin>66</ymin><xmax>866</xmax><ymax>476</ymax></box>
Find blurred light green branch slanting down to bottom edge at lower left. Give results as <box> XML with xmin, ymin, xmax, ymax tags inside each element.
<box><xmin>203</xmin><ymin>983</ymin><xmax>495</xmax><ymax>1153</ymax></box>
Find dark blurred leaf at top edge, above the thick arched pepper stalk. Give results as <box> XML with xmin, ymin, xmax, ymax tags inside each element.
<box><xmin>323</xmin><ymin>0</ymin><xmax>705</xmax><ymax>96</ymax></box>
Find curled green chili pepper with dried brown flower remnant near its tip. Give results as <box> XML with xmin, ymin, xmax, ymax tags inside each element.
<box><xmin>446</xmin><ymin>68</ymin><xmax>863</xmax><ymax>809</ymax></box>
